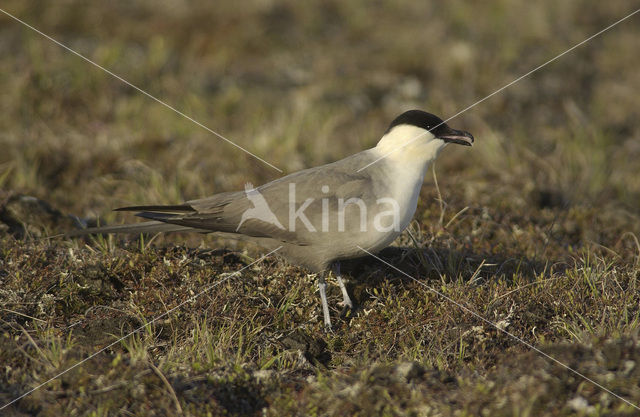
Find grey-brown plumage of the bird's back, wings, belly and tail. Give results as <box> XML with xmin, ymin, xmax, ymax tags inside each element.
<box><xmin>70</xmin><ymin>151</ymin><xmax>388</xmax><ymax>273</ymax></box>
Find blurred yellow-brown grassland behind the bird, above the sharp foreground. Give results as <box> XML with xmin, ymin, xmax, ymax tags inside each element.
<box><xmin>0</xmin><ymin>0</ymin><xmax>640</xmax><ymax>252</ymax></box>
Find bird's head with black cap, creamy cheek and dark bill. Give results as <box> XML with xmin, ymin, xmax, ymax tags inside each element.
<box><xmin>376</xmin><ymin>110</ymin><xmax>473</xmax><ymax>161</ymax></box>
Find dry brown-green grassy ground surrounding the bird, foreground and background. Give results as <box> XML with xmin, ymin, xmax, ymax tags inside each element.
<box><xmin>0</xmin><ymin>0</ymin><xmax>640</xmax><ymax>416</ymax></box>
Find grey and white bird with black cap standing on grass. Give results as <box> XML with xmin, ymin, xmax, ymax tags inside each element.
<box><xmin>69</xmin><ymin>110</ymin><xmax>474</xmax><ymax>330</ymax></box>
